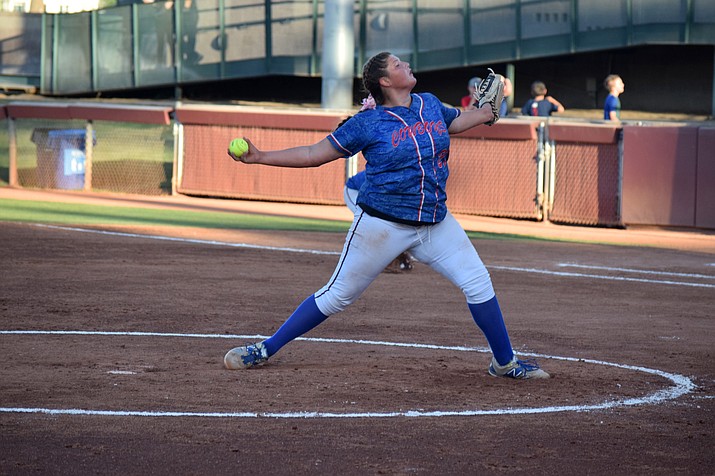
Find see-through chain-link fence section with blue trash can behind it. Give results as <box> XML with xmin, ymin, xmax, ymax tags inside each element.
<box><xmin>11</xmin><ymin>119</ymin><xmax>174</xmax><ymax>195</ymax></box>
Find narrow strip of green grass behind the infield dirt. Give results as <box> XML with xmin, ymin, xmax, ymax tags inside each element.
<box><xmin>0</xmin><ymin>199</ymin><xmax>553</xmax><ymax>241</ymax></box>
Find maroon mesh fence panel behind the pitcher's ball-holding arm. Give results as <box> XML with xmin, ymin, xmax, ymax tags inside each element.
<box><xmin>176</xmin><ymin>106</ymin><xmax>346</xmax><ymax>205</ymax></box>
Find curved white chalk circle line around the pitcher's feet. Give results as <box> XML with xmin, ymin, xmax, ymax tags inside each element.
<box><xmin>0</xmin><ymin>330</ymin><xmax>696</xmax><ymax>418</ymax></box>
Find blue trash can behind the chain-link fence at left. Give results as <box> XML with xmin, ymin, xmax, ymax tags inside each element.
<box><xmin>31</xmin><ymin>128</ymin><xmax>97</xmax><ymax>190</ymax></box>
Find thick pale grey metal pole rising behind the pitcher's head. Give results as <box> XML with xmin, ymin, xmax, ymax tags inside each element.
<box><xmin>321</xmin><ymin>0</ymin><xmax>355</xmax><ymax>109</ymax></box>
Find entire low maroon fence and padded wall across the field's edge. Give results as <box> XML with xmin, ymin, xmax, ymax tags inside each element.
<box><xmin>0</xmin><ymin>101</ymin><xmax>715</xmax><ymax>229</ymax></box>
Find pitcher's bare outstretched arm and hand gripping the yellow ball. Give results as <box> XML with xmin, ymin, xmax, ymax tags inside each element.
<box><xmin>228</xmin><ymin>138</ymin><xmax>344</xmax><ymax>168</ymax></box>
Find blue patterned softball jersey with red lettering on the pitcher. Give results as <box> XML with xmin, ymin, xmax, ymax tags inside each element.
<box><xmin>328</xmin><ymin>93</ymin><xmax>460</xmax><ymax>224</ymax></box>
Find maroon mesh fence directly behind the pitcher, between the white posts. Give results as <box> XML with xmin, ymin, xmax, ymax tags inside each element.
<box><xmin>176</xmin><ymin>106</ymin><xmax>538</xmax><ymax>219</ymax></box>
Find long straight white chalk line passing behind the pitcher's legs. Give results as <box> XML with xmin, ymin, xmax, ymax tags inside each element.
<box><xmin>32</xmin><ymin>223</ymin><xmax>715</xmax><ymax>288</ymax></box>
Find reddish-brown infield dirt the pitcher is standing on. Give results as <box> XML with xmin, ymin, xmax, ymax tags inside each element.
<box><xmin>0</xmin><ymin>190</ymin><xmax>715</xmax><ymax>475</ymax></box>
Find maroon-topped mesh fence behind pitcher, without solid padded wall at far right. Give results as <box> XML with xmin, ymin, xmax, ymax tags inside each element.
<box><xmin>0</xmin><ymin>104</ymin><xmax>622</xmax><ymax>226</ymax></box>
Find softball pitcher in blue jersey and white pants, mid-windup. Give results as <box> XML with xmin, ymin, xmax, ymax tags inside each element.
<box><xmin>224</xmin><ymin>52</ymin><xmax>549</xmax><ymax>379</ymax></box>
